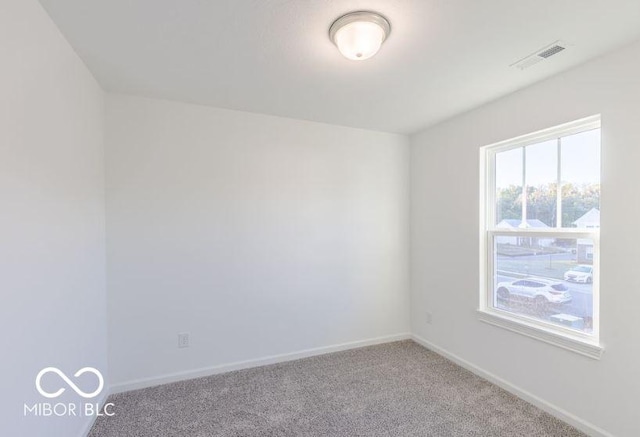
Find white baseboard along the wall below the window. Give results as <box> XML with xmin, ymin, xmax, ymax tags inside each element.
<box><xmin>411</xmin><ymin>334</ymin><xmax>613</xmax><ymax>437</ymax></box>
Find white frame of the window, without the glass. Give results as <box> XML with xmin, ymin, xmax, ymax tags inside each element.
<box><xmin>477</xmin><ymin>115</ymin><xmax>604</xmax><ymax>359</ymax></box>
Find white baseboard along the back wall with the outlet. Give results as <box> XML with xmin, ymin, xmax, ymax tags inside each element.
<box><xmin>109</xmin><ymin>333</ymin><xmax>412</xmax><ymax>394</ymax></box>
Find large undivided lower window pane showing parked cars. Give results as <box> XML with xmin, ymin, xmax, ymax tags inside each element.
<box><xmin>492</xmin><ymin>236</ymin><xmax>593</xmax><ymax>333</ymax></box>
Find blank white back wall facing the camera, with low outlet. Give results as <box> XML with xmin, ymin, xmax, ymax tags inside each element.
<box><xmin>106</xmin><ymin>96</ymin><xmax>409</xmax><ymax>388</ymax></box>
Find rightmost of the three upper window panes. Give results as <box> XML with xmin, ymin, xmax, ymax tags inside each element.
<box><xmin>561</xmin><ymin>129</ymin><xmax>600</xmax><ymax>228</ymax></box>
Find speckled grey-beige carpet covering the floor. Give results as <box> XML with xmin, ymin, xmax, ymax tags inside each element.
<box><xmin>89</xmin><ymin>340</ymin><xmax>583</xmax><ymax>437</ymax></box>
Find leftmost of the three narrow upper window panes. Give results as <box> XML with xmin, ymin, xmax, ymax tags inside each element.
<box><xmin>495</xmin><ymin>147</ymin><xmax>523</xmax><ymax>228</ymax></box>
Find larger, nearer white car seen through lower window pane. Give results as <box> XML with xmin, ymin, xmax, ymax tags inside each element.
<box><xmin>496</xmin><ymin>278</ymin><xmax>572</xmax><ymax>307</ymax></box>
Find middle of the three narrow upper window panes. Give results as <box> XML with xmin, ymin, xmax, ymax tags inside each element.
<box><xmin>525</xmin><ymin>140</ymin><xmax>558</xmax><ymax>228</ymax></box>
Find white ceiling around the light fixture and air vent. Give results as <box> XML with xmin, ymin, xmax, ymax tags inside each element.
<box><xmin>40</xmin><ymin>0</ymin><xmax>640</xmax><ymax>133</ymax></box>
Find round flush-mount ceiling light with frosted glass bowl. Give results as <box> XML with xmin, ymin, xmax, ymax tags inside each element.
<box><xmin>329</xmin><ymin>11</ymin><xmax>391</xmax><ymax>61</ymax></box>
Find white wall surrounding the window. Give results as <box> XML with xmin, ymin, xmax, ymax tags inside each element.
<box><xmin>411</xmin><ymin>39</ymin><xmax>640</xmax><ymax>436</ymax></box>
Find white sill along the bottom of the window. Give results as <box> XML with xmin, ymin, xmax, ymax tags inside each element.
<box><xmin>478</xmin><ymin>310</ymin><xmax>604</xmax><ymax>360</ymax></box>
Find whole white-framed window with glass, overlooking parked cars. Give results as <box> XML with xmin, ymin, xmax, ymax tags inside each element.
<box><xmin>479</xmin><ymin>116</ymin><xmax>602</xmax><ymax>358</ymax></box>
